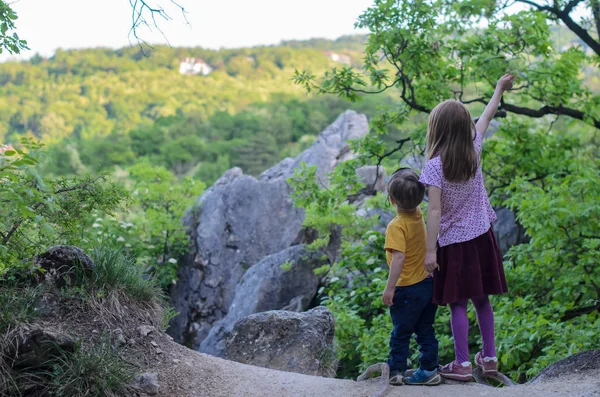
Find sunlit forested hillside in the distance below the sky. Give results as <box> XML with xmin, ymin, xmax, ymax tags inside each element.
<box><xmin>0</xmin><ymin>36</ymin><xmax>390</xmax><ymax>182</ymax></box>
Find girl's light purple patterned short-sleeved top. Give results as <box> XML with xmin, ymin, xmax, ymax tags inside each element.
<box><xmin>420</xmin><ymin>132</ymin><xmax>496</xmax><ymax>247</ymax></box>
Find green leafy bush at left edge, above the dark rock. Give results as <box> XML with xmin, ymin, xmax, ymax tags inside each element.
<box><xmin>0</xmin><ymin>138</ymin><xmax>126</xmax><ymax>274</ymax></box>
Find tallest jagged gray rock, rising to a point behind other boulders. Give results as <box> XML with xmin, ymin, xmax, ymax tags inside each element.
<box><xmin>169</xmin><ymin>111</ymin><xmax>369</xmax><ymax>349</ymax></box>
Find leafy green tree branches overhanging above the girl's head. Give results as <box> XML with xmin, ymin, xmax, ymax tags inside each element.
<box><xmin>296</xmin><ymin>0</ymin><xmax>600</xmax><ymax>128</ymax></box>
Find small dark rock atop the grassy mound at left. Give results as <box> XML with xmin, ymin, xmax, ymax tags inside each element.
<box><xmin>33</xmin><ymin>245</ymin><xmax>94</xmax><ymax>288</ymax></box>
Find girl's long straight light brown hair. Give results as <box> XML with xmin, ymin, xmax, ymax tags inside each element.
<box><xmin>427</xmin><ymin>100</ymin><xmax>479</xmax><ymax>182</ymax></box>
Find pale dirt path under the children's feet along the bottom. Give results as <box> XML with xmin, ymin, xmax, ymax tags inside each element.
<box><xmin>143</xmin><ymin>333</ymin><xmax>600</xmax><ymax>397</ymax></box>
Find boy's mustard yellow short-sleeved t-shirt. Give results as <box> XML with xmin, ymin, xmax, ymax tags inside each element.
<box><xmin>385</xmin><ymin>208</ymin><xmax>427</xmax><ymax>287</ymax></box>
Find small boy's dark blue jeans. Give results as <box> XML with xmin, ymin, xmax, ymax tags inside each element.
<box><xmin>388</xmin><ymin>278</ymin><xmax>438</xmax><ymax>372</ymax></box>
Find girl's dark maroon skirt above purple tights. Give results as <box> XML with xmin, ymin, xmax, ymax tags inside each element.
<box><xmin>433</xmin><ymin>228</ymin><xmax>508</xmax><ymax>305</ymax></box>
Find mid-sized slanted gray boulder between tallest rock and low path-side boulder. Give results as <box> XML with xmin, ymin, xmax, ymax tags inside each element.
<box><xmin>200</xmin><ymin>245</ymin><xmax>323</xmax><ymax>356</ymax></box>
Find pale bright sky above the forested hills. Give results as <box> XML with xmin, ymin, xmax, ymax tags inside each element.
<box><xmin>0</xmin><ymin>0</ymin><xmax>373</xmax><ymax>60</ymax></box>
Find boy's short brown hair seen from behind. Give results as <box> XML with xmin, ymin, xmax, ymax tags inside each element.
<box><xmin>387</xmin><ymin>168</ymin><xmax>425</xmax><ymax>210</ymax></box>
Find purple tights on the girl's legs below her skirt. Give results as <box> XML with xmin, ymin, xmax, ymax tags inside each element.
<box><xmin>450</xmin><ymin>295</ymin><xmax>496</xmax><ymax>363</ymax></box>
